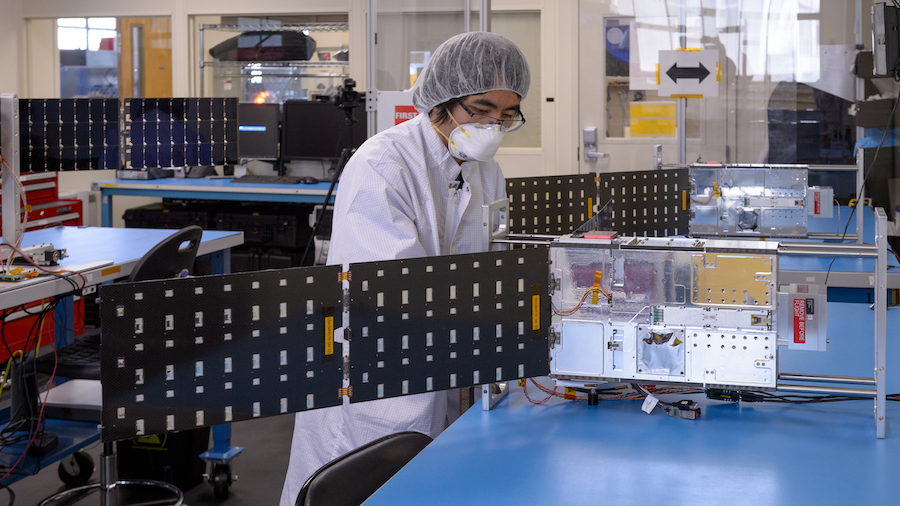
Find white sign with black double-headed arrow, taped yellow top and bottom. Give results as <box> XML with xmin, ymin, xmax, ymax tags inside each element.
<box><xmin>656</xmin><ymin>49</ymin><xmax>722</xmax><ymax>98</ymax></box>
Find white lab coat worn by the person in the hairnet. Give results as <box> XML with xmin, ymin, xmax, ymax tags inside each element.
<box><xmin>281</xmin><ymin>114</ymin><xmax>506</xmax><ymax>506</ymax></box>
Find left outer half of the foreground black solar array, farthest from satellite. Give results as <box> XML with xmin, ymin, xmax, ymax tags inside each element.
<box><xmin>100</xmin><ymin>266</ymin><xmax>343</xmax><ymax>441</ymax></box>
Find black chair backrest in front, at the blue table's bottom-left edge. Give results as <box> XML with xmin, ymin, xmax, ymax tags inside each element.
<box><xmin>295</xmin><ymin>432</ymin><xmax>431</xmax><ymax>506</ymax></box>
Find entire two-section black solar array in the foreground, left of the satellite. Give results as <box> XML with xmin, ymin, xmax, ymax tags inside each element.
<box><xmin>100</xmin><ymin>249</ymin><xmax>550</xmax><ymax>441</ymax></box>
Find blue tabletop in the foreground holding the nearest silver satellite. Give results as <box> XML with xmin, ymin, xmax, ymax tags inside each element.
<box><xmin>365</xmin><ymin>304</ymin><xmax>900</xmax><ymax>506</ymax></box>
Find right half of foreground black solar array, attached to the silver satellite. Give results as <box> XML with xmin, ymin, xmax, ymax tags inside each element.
<box><xmin>350</xmin><ymin>248</ymin><xmax>550</xmax><ymax>402</ymax></box>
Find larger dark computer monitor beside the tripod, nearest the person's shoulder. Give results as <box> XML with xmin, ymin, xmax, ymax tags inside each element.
<box><xmin>281</xmin><ymin>100</ymin><xmax>366</xmax><ymax>160</ymax></box>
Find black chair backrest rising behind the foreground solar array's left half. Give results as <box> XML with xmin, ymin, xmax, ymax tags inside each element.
<box><xmin>128</xmin><ymin>225</ymin><xmax>203</xmax><ymax>281</ymax></box>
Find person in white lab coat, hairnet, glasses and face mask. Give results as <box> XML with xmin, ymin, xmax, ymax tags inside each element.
<box><xmin>281</xmin><ymin>32</ymin><xmax>530</xmax><ymax>506</ymax></box>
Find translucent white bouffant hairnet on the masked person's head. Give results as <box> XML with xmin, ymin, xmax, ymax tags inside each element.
<box><xmin>413</xmin><ymin>32</ymin><xmax>531</xmax><ymax>114</ymax></box>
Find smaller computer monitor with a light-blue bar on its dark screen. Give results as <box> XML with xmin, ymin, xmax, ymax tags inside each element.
<box><xmin>238</xmin><ymin>102</ymin><xmax>281</xmax><ymax>160</ymax></box>
